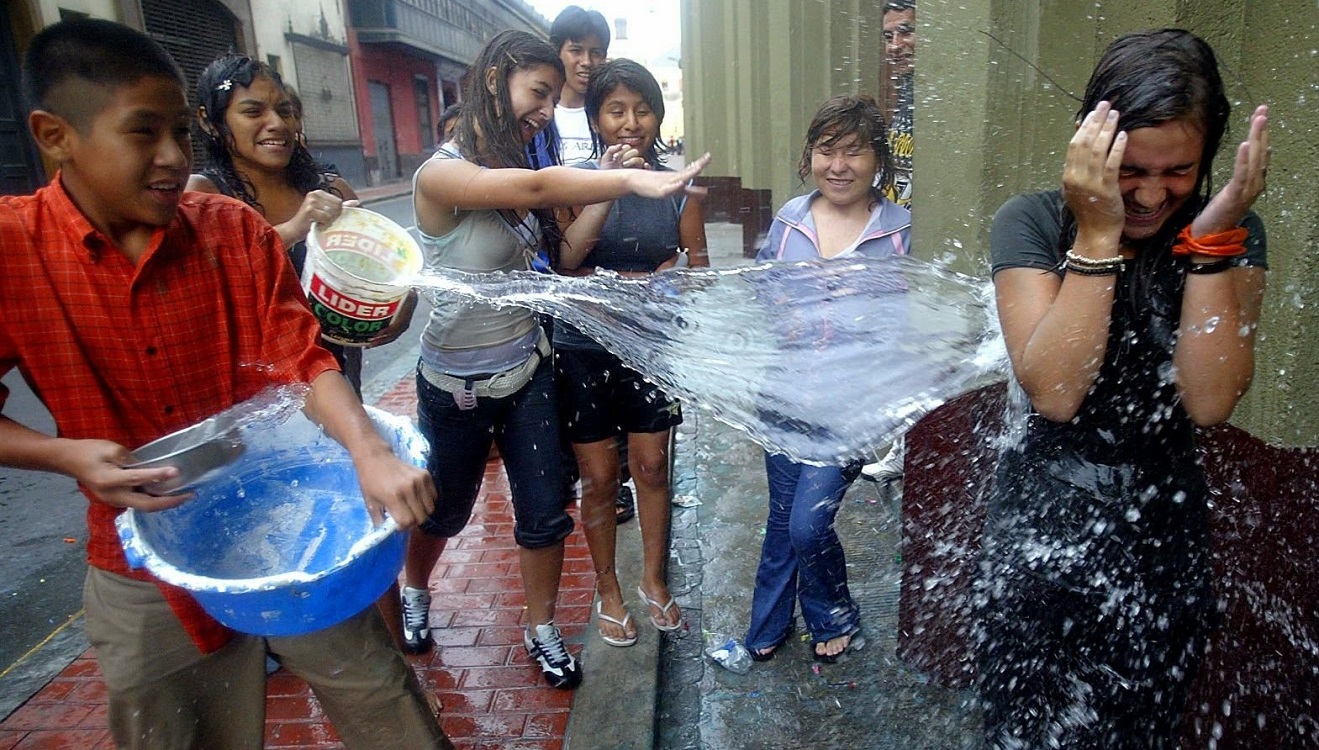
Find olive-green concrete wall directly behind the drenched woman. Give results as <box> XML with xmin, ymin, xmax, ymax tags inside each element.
<box><xmin>944</xmin><ymin>0</ymin><xmax>1319</xmax><ymax>446</ymax></box>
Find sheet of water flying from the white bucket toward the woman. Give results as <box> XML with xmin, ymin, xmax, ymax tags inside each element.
<box><xmin>414</xmin><ymin>256</ymin><xmax>1006</xmax><ymax>464</ymax></box>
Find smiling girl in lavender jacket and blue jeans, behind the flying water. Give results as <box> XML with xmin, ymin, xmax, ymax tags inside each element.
<box><xmin>745</xmin><ymin>96</ymin><xmax>911</xmax><ymax>662</ymax></box>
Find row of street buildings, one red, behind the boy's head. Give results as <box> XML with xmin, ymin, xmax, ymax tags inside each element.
<box><xmin>0</xmin><ymin>0</ymin><xmax>549</xmax><ymax>194</ymax></box>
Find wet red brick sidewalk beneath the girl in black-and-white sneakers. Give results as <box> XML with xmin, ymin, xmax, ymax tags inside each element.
<box><xmin>0</xmin><ymin>376</ymin><xmax>595</xmax><ymax>750</ymax></box>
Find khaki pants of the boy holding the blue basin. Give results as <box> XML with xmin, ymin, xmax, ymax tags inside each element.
<box><xmin>83</xmin><ymin>568</ymin><xmax>452</xmax><ymax>750</ymax></box>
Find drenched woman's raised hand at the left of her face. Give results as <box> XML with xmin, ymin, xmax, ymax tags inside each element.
<box><xmin>1063</xmin><ymin>101</ymin><xmax>1126</xmax><ymax>245</ymax></box>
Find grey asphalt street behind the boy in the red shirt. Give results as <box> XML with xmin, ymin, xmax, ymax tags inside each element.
<box><xmin>0</xmin><ymin>188</ymin><xmax>430</xmax><ymax>718</ymax></box>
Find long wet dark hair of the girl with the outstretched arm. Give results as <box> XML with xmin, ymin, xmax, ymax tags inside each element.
<box><xmin>452</xmin><ymin>29</ymin><xmax>565</xmax><ymax>264</ymax></box>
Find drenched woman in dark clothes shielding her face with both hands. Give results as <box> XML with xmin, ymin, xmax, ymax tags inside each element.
<box><xmin>977</xmin><ymin>29</ymin><xmax>1269</xmax><ymax>749</ymax></box>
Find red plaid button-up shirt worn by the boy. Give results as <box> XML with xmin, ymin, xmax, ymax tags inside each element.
<box><xmin>0</xmin><ymin>175</ymin><xmax>338</xmax><ymax>652</ymax></box>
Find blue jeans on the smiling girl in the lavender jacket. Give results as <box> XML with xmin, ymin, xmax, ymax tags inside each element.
<box><xmin>745</xmin><ymin>453</ymin><xmax>861</xmax><ymax>650</ymax></box>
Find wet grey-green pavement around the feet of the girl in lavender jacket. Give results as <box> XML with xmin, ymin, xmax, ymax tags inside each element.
<box><xmin>656</xmin><ymin>414</ymin><xmax>981</xmax><ymax>750</ymax></box>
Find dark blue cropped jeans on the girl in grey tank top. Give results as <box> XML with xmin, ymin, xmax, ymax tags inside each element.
<box><xmin>417</xmin><ymin>361</ymin><xmax>572</xmax><ymax>550</ymax></box>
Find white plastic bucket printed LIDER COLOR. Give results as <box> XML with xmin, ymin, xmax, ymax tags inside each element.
<box><xmin>302</xmin><ymin>207</ymin><xmax>422</xmax><ymax>347</ymax></box>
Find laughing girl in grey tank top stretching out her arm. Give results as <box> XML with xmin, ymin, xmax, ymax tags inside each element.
<box><xmin>404</xmin><ymin>32</ymin><xmax>708</xmax><ymax>688</ymax></box>
